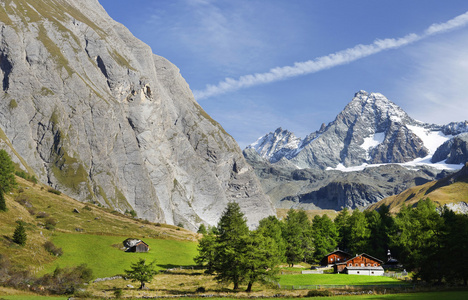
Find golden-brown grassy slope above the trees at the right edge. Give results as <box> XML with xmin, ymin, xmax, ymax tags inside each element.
<box><xmin>368</xmin><ymin>163</ymin><xmax>468</xmax><ymax>213</ymax></box>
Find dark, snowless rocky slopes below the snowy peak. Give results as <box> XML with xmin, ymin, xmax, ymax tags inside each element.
<box><xmin>244</xmin><ymin>149</ymin><xmax>448</xmax><ymax>210</ymax></box>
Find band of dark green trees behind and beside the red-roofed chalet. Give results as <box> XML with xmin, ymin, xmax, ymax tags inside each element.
<box><xmin>195</xmin><ymin>199</ymin><xmax>468</xmax><ymax>291</ymax></box>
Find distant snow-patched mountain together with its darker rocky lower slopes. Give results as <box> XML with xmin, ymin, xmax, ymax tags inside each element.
<box><xmin>244</xmin><ymin>91</ymin><xmax>468</xmax><ymax>210</ymax></box>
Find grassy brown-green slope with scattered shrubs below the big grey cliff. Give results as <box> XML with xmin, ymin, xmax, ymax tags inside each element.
<box><xmin>0</xmin><ymin>177</ymin><xmax>197</xmax><ymax>276</ymax></box>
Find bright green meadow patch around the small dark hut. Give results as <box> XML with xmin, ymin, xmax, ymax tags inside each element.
<box><xmin>42</xmin><ymin>233</ymin><xmax>198</xmax><ymax>278</ymax></box>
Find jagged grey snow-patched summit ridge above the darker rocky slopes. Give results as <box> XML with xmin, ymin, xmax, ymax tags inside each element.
<box><xmin>249</xmin><ymin>90</ymin><xmax>468</xmax><ymax>169</ymax></box>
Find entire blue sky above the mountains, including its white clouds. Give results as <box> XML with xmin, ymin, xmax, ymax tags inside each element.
<box><xmin>99</xmin><ymin>0</ymin><xmax>468</xmax><ymax>148</ymax></box>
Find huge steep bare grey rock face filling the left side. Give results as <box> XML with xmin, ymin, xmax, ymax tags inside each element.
<box><xmin>0</xmin><ymin>0</ymin><xmax>274</xmax><ymax>229</ymax></box>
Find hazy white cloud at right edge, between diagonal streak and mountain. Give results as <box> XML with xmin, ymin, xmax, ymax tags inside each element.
<box><xmin>397</xmin><ymin>32</ymin><xmax>468</xmax><ymax>124</ymax></box>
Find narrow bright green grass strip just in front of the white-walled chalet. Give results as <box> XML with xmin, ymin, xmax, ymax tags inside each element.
<box><xmin>279</xmin><ymin>274</ymin><xmax>405</xmax><ymax>286</ymax></box>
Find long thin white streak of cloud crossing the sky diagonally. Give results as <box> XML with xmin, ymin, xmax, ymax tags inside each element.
<box><xmin>194</xmin><ymin>12</ymin><xmax>468</xmax><ymax>100</ymax></box>
